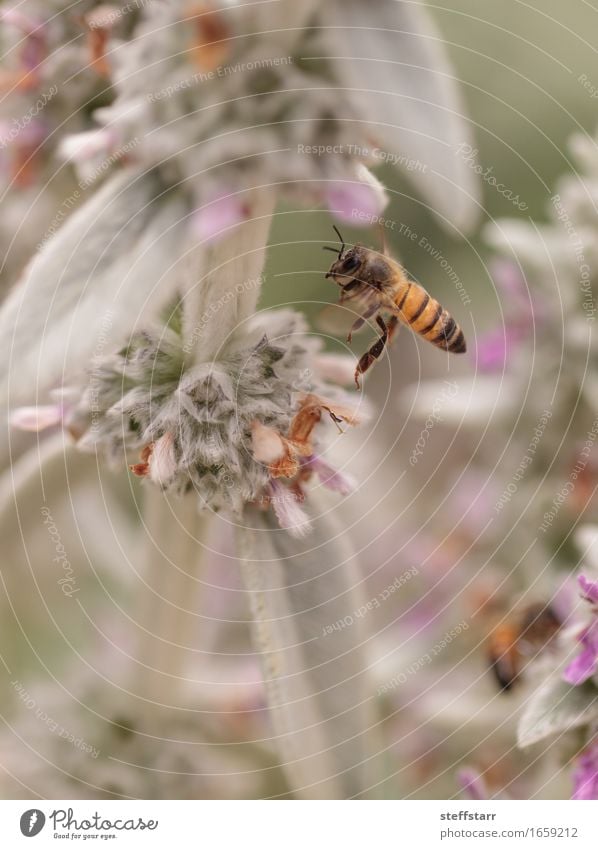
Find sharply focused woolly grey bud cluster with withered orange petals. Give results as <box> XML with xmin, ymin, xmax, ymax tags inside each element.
<box><xmin>66</xmin><ymin>311</ymin><xmax>356</xmax><ymax>533</ymax></box>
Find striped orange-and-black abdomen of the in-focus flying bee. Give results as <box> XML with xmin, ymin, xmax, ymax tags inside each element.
<box><xmin>395</xmin><ymin>281</ymin><xmax>467</xmax><ymax>354</ymax></box>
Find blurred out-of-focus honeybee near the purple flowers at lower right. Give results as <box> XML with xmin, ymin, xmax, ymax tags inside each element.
<box><xmin>487</xmin><ymin>602</ymin><xmax>562</xmax><ymax>691</ymax></box>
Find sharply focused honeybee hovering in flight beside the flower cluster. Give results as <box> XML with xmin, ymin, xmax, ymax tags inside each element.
<box><xmin>324</xmin><ymin>227</ymin><xmax>466</xmax><ymax>389</ymax></box>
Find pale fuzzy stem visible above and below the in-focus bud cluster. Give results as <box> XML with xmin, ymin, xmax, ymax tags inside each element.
<box><xmin>136</xmin><ymin>189</ymin><xmax>275</xmax><ymax>717</ymax></box>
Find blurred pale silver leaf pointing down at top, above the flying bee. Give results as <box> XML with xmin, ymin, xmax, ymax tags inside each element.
<box><xmin>321</xmin><ymin>0</ymin><xmax>479</xmax><ymax>229</ymax></box>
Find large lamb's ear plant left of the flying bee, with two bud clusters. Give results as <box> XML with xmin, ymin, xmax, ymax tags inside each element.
<box><xmin>0</xmin><ymin>0</ymin><xmax>475</xmax><ymax>798</ymax></box>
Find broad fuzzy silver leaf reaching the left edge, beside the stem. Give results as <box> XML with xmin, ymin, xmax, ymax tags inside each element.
<box><xmin>0</xmin><ymin>169</ymin><xmax>185</xmax><ymax>404</ymax></box>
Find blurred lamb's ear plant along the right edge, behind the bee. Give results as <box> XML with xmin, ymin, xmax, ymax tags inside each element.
<box><xmin>396</xmin><ymin>124</ymin><xmax>598</xmax><ymax>799</ymax></box>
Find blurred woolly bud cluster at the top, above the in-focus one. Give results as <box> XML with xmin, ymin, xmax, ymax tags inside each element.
<box><xmin>68</xmin><ymin>4</ymin><xmax>394</xmax><ymax>234</ymax></box>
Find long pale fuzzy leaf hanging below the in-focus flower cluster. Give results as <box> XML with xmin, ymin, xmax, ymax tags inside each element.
<box><xmin>237</xmin><ymin>493</ymin><xmax>376</xmax><ymax>799</ymax></box>
